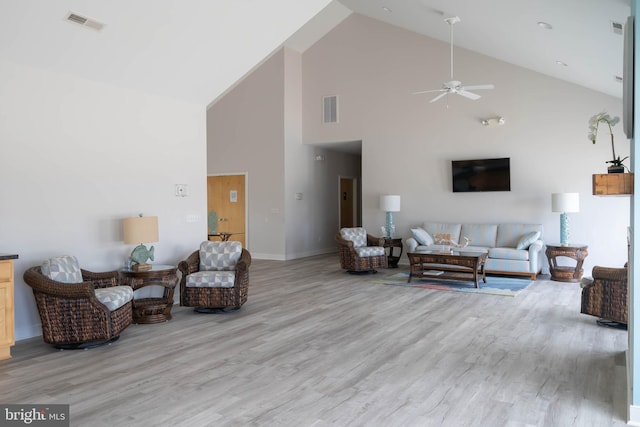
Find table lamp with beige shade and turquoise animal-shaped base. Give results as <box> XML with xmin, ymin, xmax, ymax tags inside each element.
<box><xmin>122</xmin><ymin>214</ymin><xmax>158</xmax><ymax>271</ymax></box>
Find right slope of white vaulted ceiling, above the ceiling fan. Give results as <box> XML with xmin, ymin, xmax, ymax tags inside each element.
<box><xmin>340</xmin><ymin>0</ymin><xmax>631</xmax><ymax>98</ymax></box>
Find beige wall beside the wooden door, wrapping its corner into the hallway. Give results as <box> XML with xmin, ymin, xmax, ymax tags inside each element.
<box><xmin>207</xmin><ymin>49</ymin><xmax>360</xmax><ymax>260</ymax></box>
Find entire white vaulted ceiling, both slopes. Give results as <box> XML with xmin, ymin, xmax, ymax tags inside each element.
<box><xmin>0</xmin><ymin>0</ymin><xmax>630</xmax><ymax>105</ymax></box>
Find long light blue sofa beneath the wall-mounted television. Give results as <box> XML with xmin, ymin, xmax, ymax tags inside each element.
<box><xmin>405</xmin><ymin>222</ymin><xmax>544</xmax><ymax>280</ymax></box>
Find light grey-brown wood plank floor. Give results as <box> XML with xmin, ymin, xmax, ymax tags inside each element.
<box><xmin>0</xmin><ymin>255</ymin><xmax>627</xmax><ymax>427</ymax></box>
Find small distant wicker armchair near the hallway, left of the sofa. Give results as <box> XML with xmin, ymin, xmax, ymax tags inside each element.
<box><xmin>336</xmin><ymin>227</ymin><xmax>388</xmax><ymax>273</ymax></box>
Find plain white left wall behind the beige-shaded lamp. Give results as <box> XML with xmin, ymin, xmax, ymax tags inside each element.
<box><xmin>0</xmin><ymin>62</ymin><xmax>206</xmax><ymax>340</ymax></box>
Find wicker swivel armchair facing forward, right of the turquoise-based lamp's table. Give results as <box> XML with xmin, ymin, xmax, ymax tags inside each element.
<box><xmin>178</xmin><ymin>241</ymin><xmax>251</xmax><ymax>313</ymax></box>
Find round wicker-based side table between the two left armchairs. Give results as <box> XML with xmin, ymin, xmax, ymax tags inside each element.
<box><xmin>120</xmin><ymin>264</ymin><xmax>178</xmax><ymax>323</ymax></box>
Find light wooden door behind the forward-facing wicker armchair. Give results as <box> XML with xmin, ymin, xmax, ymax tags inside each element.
<box><xmin>207</xmin><ymin>175</ymin><xmax>246</xmax><ymax>248</ymax></box>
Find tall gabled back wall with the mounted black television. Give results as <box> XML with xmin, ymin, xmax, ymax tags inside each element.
<box><xmin>302</xmin><ymin>14</ymin><xmax>630</xmax><ymax>273</ymax></box>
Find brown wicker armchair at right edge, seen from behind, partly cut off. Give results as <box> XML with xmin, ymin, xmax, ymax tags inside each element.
<box><xmin>580</xmin><ymin>265</ymin><xmax>629</xmax><ymax>328</ymax></box>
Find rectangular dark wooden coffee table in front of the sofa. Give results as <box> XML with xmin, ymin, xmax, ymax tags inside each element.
<box><xmin>407</xmin><ymin>251</ymin><xmax>487</xmax><ymax>288</ymax></box>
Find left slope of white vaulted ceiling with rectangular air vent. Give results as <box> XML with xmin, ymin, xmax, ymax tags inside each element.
<box><xmin>0</xmin><ymin>0</ymin><xmax>331</xmax><ymax>105</ymax></box>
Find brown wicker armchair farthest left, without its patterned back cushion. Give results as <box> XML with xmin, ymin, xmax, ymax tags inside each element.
<box><xmin>23</xmin><ymin>258</ymin><xmax>133</xmax><ymax>349</ymax></box>
